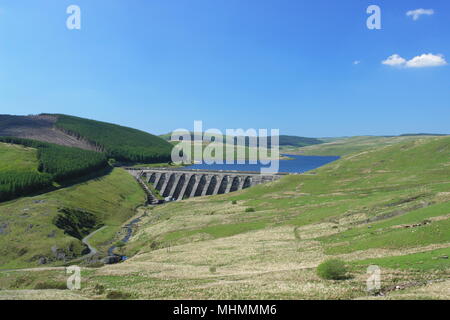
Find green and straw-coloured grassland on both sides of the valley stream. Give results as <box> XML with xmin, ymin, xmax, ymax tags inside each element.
<box><xmin>0</xmin><ymin>117</ymin><xmax>450</xmax><ymax>299</ymax></box>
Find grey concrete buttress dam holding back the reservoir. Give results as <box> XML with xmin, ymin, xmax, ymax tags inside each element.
<box><xmin>127</xmin><ymin>168</ymin><xmax>284</xmax><ymax>203</ymax></box>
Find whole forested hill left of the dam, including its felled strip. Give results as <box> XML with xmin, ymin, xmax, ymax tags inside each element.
<box><xmin>0</xmin><ymin>114</ymin><xmax>173</xmax><ymax>201</ymax></box>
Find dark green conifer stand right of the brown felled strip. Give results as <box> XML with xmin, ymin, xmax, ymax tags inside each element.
<box><xmin>50</xmin><ymin>114</ymin><xmax>172</xmax><ymax>163</ymax></box>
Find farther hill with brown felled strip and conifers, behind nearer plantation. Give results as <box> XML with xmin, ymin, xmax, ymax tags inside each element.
<box><xmin>0</xmin><ymin>114</ymin><xmax>173</xmax><ymax>163</ymax></box>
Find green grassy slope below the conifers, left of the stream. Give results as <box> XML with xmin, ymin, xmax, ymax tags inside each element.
<box><xmin>0</xmin><ymin>169</ymin><xmax>145</xmax><ymax>269</ymax></box>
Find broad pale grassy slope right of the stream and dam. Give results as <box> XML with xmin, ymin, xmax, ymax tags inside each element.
<box><xmin>67</xmin><ymin>137</ymin><xmax>450</xmax><ymax>299</ymax></box>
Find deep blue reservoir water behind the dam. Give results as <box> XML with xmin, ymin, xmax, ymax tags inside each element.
<box><xmin>184</xmin><ymin>154</ymin><xmax>340</xmax><ymax>173</ymax></box>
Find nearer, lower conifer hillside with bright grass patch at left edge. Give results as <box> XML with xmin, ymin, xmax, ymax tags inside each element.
<box><xmin>0</xmin><ymin>137</ymin><xmax>108</xmax><ymax>202</ymax></box>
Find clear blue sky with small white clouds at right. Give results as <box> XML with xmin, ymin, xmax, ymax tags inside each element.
<box><xmin>0</xmin><ymin>0</ymin><xmax>450</xmax><ymax>137</ymax></box>
